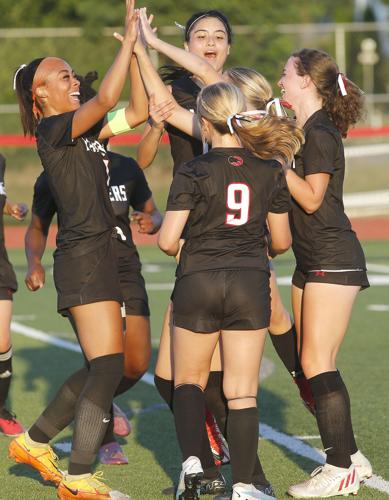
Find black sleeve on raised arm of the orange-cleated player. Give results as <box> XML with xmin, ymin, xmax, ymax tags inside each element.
<box><xmin>37</xmin><ymin>111</ymin><xmax>75</xmax><ymax>148</ymax></box>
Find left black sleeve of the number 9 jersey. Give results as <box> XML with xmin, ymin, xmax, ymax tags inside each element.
<box><xmin>166</xmin><ymin>164</ymin><xmax>197</xmax><ymax>211</ymax></box>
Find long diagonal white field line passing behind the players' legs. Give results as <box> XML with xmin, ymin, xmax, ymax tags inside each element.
<box><xmin>11</xmin><ymin>321</ymin><xmax>389</xmax><ymax>495</ymax></box>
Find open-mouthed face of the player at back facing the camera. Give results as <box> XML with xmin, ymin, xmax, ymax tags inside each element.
<box><xmin>185</xmin><ymin>17</ymin><xmax>230</xmax><ymax>71</ymax></box>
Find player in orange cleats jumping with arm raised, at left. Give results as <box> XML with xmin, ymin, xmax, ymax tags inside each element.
<box><xmin>9</xmin><ymin>0</ymin><xmax>144</xmax><ymax>499</ymax></box>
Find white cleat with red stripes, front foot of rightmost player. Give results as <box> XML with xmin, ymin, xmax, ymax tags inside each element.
<box><xmin>288</xmin><ymin>464</ymin><xmax>359</xmax><ymax>498</ymax></box>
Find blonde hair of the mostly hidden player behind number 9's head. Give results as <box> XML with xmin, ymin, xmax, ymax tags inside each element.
<box><xmin>224</xmin><ymin>67</ymin><xmax>273</xmax><ymax>109</ymax></box>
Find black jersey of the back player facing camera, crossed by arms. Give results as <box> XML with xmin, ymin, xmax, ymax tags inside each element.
<box><xmin>166</xmin><ymin>76</ymin><xmax>203</xmax><ymax>175</ymax></box>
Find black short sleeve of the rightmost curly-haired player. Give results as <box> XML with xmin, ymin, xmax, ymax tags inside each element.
<box><xmin>302</xmin><ymin>127</ymin><xmax>339</xmax><ymax>175</ymax></box>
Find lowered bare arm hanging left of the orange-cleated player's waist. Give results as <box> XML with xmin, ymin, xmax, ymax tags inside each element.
<box><xmin>24</xmin><ymin>213</ymin><xmax>52</xmax><ymax>292</ymax></box>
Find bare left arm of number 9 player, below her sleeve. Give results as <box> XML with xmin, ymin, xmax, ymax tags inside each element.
<box><xmin>158</xmin><ymin>210</ymin><xmax>190</xmax><ymax>257</ymax></box>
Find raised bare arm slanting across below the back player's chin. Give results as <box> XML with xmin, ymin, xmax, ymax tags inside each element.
<box><xmin>140</xmin><ymin>8</ymin><xmax>220</xmax><ymax>85</ymax></box>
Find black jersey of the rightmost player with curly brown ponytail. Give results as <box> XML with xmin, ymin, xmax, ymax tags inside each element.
<box><xmin>290</xmin><ymin>109</ymin><xmax>366</xmax><ymax>272</ymax></box>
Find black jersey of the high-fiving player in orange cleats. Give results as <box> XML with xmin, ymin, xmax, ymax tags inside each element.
<box><xmin>36</xmin><ymin>111</ymin><xmax>115</xmax><ymax>255</ymax></box>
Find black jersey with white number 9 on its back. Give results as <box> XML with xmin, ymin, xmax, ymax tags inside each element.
<box><xmin>167</xmin><ymin>148</ymin><xmax>290</xmax><ymax>277</ymax></box>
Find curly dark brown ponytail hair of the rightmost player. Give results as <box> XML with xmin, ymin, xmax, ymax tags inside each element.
<box><xmin>292</xmin><ymin>49</ymin><xmax>364</xmax><ymax>137</ymax></box>
